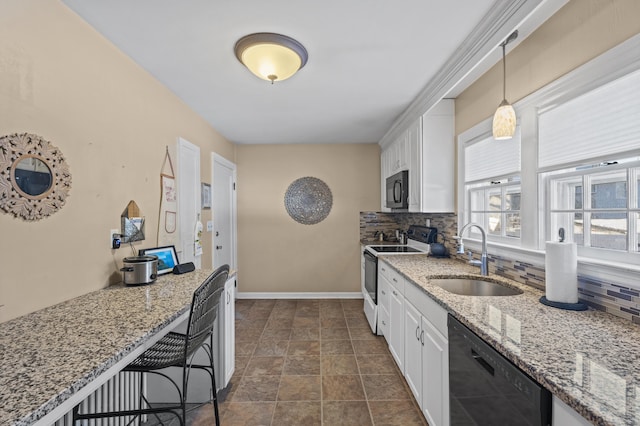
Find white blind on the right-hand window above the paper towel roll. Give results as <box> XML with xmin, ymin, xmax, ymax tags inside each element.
<box><xmin>538</xmin><ymin>71</ymin><xmax>640</xmax><ymax>168</ymax></box>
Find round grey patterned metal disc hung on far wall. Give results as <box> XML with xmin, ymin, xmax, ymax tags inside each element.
<box><xmin>284</xmin><ymin>177</ymin><xmax>333</xmax><ymax>225</ymax></box>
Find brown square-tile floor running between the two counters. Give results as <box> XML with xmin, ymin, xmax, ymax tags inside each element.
<box><xmin>190</xmin><ymin>300</ymin><xmax>427</xmax><ymax>426</ymax></box>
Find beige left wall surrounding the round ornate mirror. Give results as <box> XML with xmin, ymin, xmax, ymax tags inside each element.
<box><xmin>0</xmin><ymin>0</ymin><xmax>235</xmax><ymax>321</ymax></box>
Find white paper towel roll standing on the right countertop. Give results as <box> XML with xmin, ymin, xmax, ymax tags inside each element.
<box><xmin>544</xmin><ymin>241</ymin><xmax>578</xmax><ymax>303</ymax></box>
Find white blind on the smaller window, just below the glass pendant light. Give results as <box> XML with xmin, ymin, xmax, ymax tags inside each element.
<box><xmin>464</xmin><ymin>126</ymin><xmax>520</xmax><ymax>182</ymax></box>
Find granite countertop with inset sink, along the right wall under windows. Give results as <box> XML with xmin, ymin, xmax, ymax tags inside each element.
<box><xmin>379</xmin><ymin>255</ymin><xmax>640</xmax><ymax>425</ymax></box>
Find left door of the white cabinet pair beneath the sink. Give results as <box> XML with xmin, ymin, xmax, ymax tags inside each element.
<box><xmin>404</xmin><ymin>300</ymin><xmax>422</xmax><ymax>402</ymax></box>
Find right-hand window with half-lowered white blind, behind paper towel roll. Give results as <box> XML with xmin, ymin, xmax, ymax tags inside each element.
<box><xmin>538</xmin><ymin>67</ymin><xmax>640</xmax><ymax>261</ymax></box>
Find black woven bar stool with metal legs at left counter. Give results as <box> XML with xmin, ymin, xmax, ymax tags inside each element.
<box><xmin>73</xmin><ymin>265</ymin><xmax>229</xmax><ymax>426</ymax></box>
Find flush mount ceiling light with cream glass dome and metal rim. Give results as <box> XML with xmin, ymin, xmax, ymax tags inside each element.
<box><xmin>234</xmin><ymin>33</ymin><xmax>309</xmax><ymax>84</ymax></box>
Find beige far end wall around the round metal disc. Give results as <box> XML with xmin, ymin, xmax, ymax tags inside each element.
<box><xmin>237</xmin><ymin>144</ymin><xmax>380</xmax><ymax>293</ymax></box>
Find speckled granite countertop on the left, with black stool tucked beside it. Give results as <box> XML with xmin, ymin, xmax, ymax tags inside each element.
<box><xmin>0</xmin><ymin>270</ymin><xmax>232</xmax><ymax>425</ymax></box>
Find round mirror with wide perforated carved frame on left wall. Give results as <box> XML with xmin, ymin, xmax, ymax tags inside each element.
<box><xmin>0</xmin><ymin>133</ymin><xmax>71</xmax><ymax>220</ymax></box>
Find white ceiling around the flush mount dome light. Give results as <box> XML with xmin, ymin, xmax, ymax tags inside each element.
<box><xmin>63</xmin><ymin>0</ymin><xmax>560</xmax><ymax>144</ymax></box>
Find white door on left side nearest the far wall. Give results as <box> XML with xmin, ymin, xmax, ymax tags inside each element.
<box><xmin>211</xmin><ymin>153</ymin><xmax>237</xmax><ymax>269</ymax></box>
